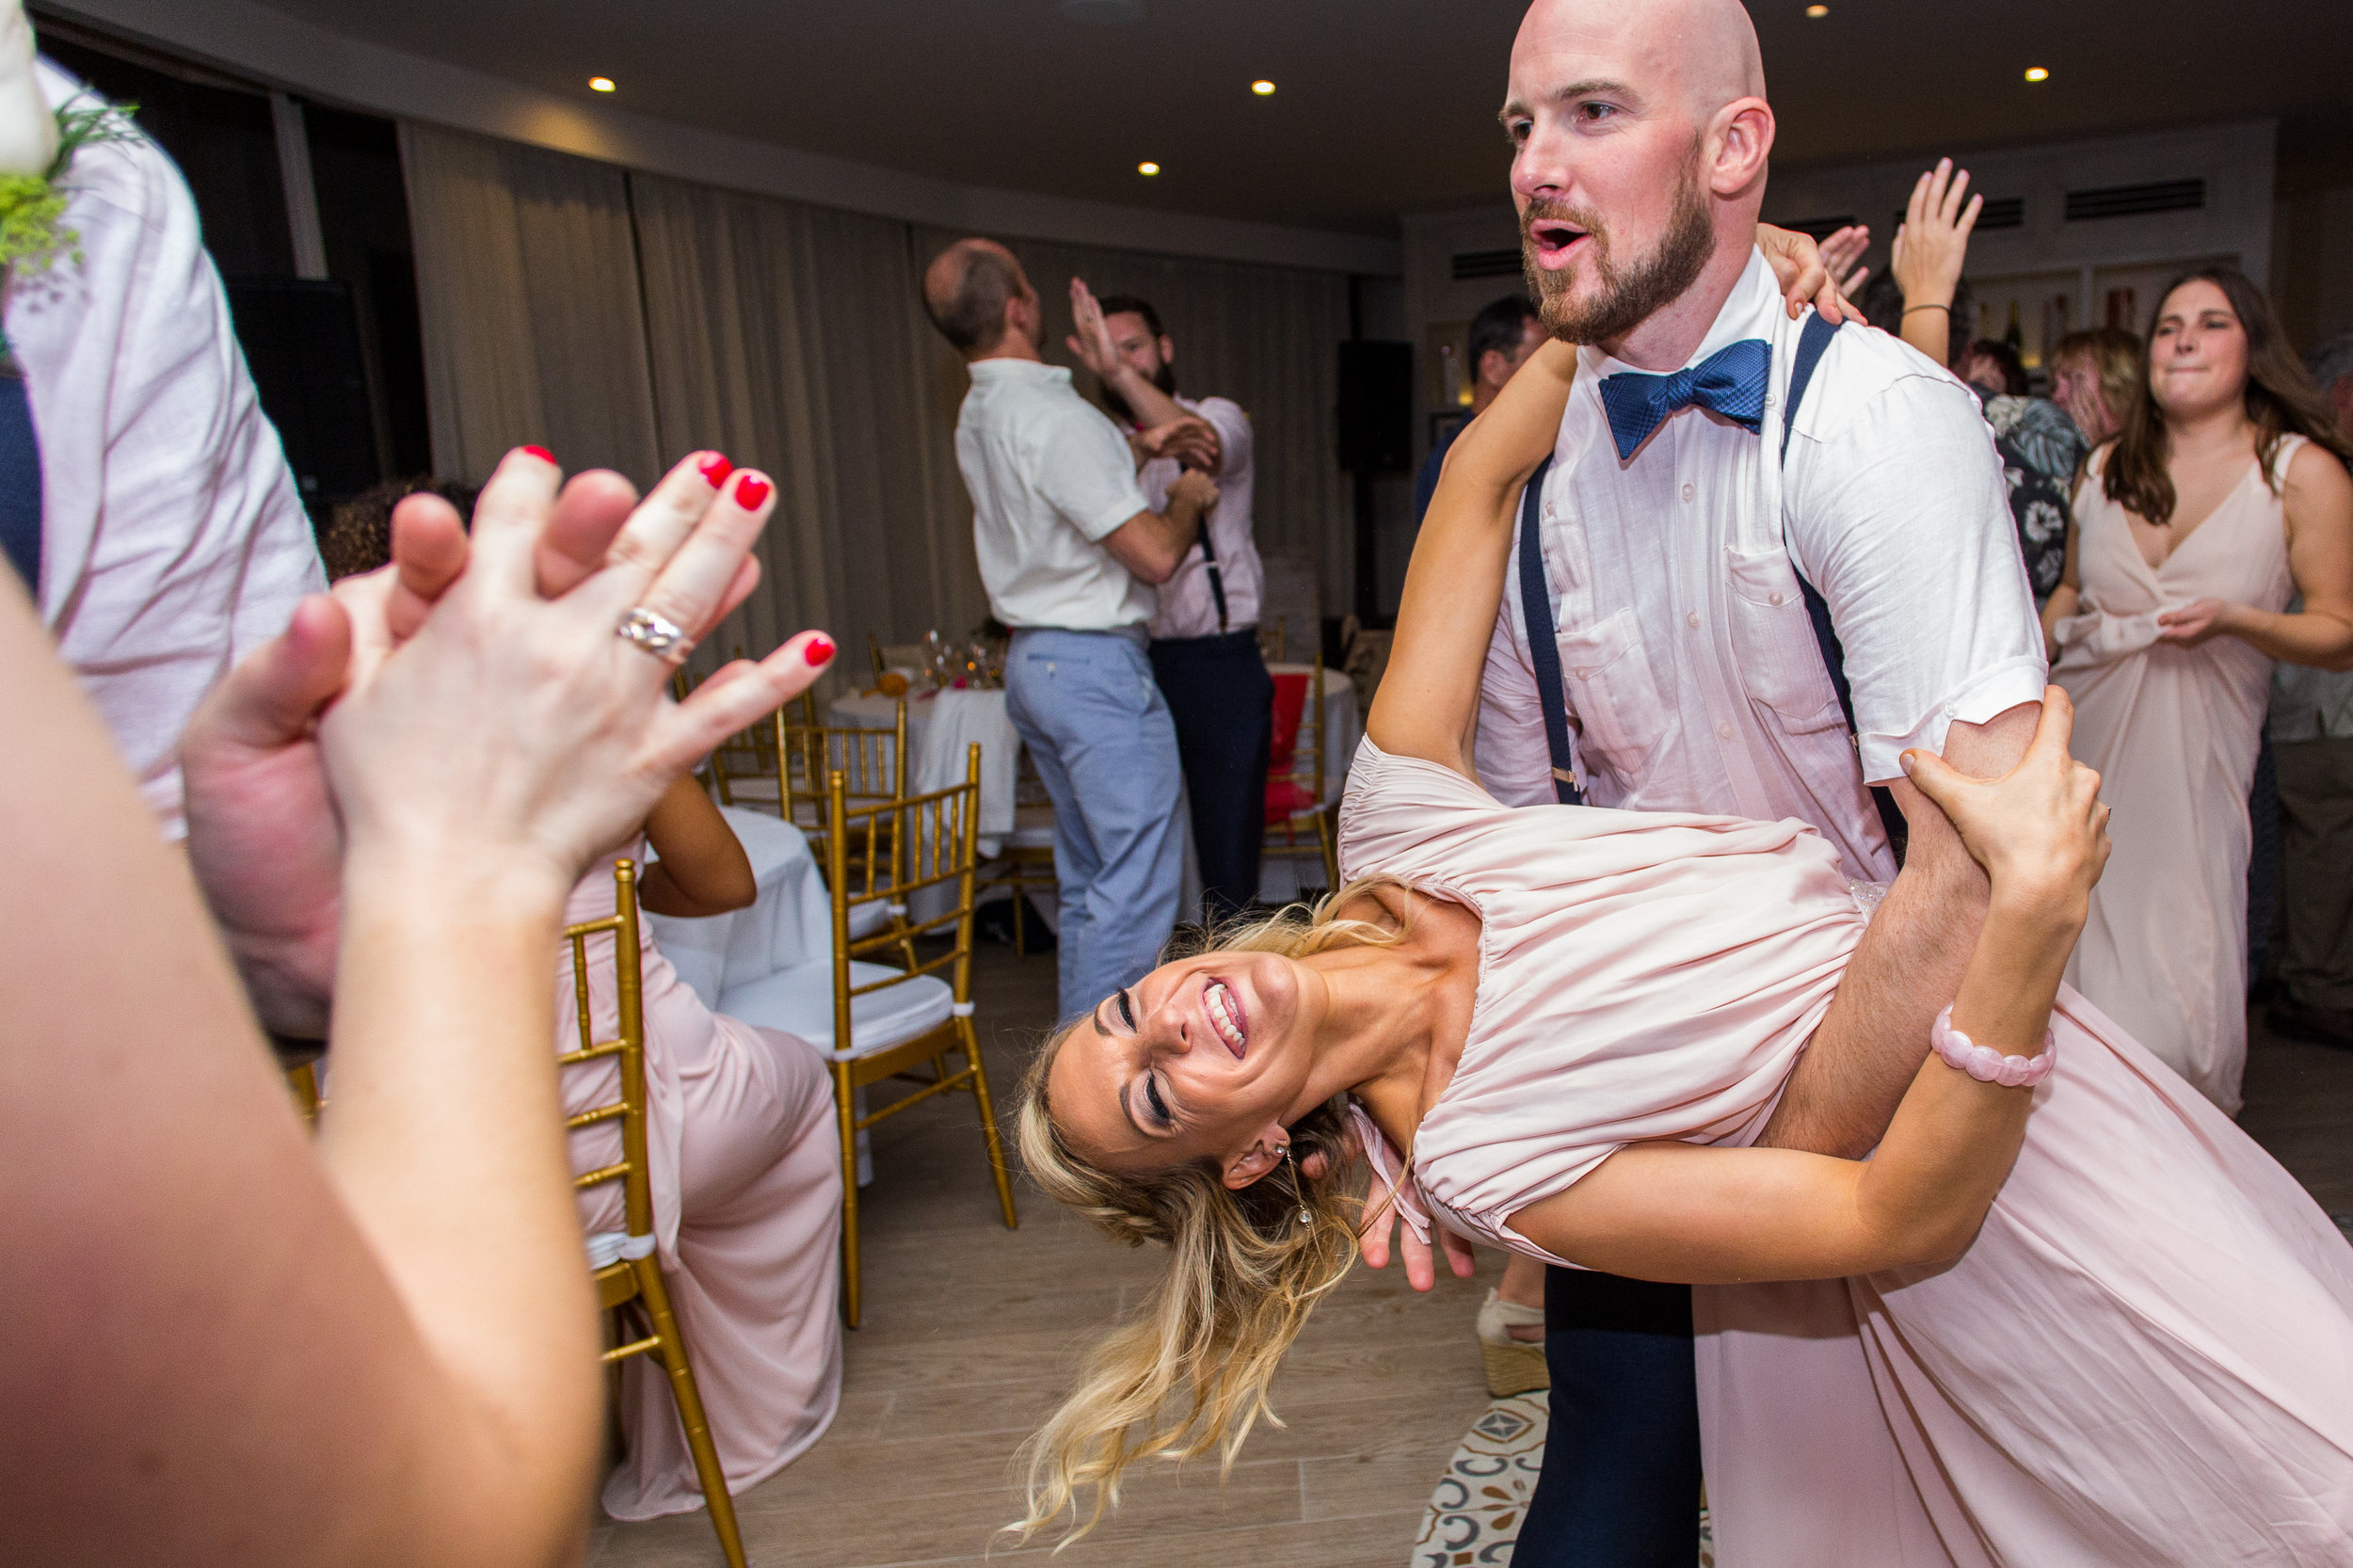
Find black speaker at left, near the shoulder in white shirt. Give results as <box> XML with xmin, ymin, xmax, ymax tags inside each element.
<box><xmin>229</xmin><ymin>278</ymin><xmax>384</xmax><ymax>516</ymax></box>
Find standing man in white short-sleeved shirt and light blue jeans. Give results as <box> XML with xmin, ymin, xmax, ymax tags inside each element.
<box><xmin>922</xmin><ymin>240</ymin><xmax>1217</xmax><ymax>1017</ymax></box>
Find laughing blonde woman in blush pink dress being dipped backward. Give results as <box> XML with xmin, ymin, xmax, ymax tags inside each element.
<box><xmin>1021</xmin><ymin>344</ymin><xmax>2353</xmax><ymax>1568</ymax></box>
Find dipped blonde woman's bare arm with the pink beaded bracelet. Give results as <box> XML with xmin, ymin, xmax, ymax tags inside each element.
<box><xmin>1513</xmin><ymin>687</ymin><xmax>2106</xmax><ymax>1283</ymax></box>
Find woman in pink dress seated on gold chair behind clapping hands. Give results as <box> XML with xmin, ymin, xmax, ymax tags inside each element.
<box><xmin>555</xmin><ymin>776</ymin><xmax>842</xmax><ymax>1518</ymax></box>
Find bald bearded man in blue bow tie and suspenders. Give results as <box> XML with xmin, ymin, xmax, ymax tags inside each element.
<box><xmin>1374</xmin><ymin>0</ymin><xmax>2045</xmax><ymax>1568</ymax></box>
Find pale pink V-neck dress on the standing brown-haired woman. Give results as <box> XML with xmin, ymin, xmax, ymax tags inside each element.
<box><xmin>2052</xmin><ymin>436</ymin><xmax>2304</xmax><ymax>1116</ymax></box>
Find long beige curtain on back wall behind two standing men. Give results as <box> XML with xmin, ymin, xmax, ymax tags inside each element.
<box><xmin>400</xmin><ymin>122</ymin><xmax>1351</xmax><ymax>664</ymax></box>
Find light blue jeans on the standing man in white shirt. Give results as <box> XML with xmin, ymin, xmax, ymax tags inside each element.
<box><xmin>1005</xmin><ymin>626</ymin><xmax>1184</xmax><ymax>1019</ymax></box>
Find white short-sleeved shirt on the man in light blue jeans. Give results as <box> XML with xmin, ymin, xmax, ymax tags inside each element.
<box><xmin>955</xmin><ymin>360</ymin><xmax>1153</xmax><ymax>631</ymax></box>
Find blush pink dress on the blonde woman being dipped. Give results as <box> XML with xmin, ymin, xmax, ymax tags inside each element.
<box><xmin>1341</xmin><ymin>739</ymin><xmax>2353</xmax><ymax>1568</ymax></box>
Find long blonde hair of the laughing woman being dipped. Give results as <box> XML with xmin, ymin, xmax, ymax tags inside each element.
<box><xmin>1007</xmin><ymin>878</ymin><xmax>1405</xmax><ymax>1544</ymax></box>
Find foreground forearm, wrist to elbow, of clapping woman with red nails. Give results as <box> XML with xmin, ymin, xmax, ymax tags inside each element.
<box><xmin>318</xmin><ymin>850</ymin><xmax>600</xmax><ymax>1540</ymax></box>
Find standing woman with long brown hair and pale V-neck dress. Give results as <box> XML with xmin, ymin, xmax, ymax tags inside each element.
<box><xmin>2042</xmin><ymin>266</ymin><xmax>2353</xmax><ymax>1113</ymax></box>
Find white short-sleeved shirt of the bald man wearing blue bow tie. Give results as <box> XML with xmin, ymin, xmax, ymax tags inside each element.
<box><xmin>1478</xmin><ymin>254</ymin><xmax>2047</xmax><ymax>881</ymax></box>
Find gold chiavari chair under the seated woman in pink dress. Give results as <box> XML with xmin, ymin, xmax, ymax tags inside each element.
<box><xmin>555</xmin><ymin>859</ymin><xmax>744</xmax><ymax>1568</ymax></box>
